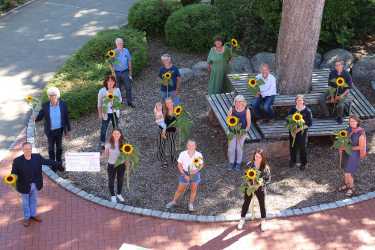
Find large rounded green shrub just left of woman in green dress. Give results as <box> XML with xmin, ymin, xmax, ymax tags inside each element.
<box><xmin>165</xmin><ymin>4</ymin><xmax>221</xmax><ymax>51</ymax></box>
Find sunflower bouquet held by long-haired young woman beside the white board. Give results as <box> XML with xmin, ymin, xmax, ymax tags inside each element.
<box><xmin>115</xmin><ymin>143</ymin><xmax>139</xmax><ymax>190</ymax></box>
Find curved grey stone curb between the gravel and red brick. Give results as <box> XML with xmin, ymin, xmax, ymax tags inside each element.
<box><xmin>26</xmin><ymin>112</ymin><xmax>375</xmax><ymax>223</ymax></box>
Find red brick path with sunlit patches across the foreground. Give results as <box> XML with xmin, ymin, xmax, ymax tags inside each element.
<box><xmin>0</xmin><ymin>146</ymin><xmax>375</xmax><ymax>250</ymax></box>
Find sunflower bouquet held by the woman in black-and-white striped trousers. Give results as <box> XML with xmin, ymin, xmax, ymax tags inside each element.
<box><xmin>169</xmin><ymin>105</ymin><xmax>193</xmax><ymax>147</ymax></box>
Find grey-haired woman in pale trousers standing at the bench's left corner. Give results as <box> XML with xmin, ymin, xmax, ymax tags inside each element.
<box><xmin>227</xmin><ymin>95</ymin><xmax>251</xmax><ymax>171</ymax></box>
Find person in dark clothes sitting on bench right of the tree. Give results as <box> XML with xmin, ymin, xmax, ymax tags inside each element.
<box><xmin>320</xmin><ymin>60</ymin><xmax>353</xmax><ymax>124</ymax></box>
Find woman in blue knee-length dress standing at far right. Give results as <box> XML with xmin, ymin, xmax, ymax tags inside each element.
<box><xmin>339</xmin><ymin>115</ymin><xmax>367</xmax><ymax>196</ymax></box>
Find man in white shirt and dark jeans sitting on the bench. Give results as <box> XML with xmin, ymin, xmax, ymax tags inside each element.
<box><xmin>251</xmin><ymin>63</ymin><xmax>277</xmax><ymax>122</ymax></box>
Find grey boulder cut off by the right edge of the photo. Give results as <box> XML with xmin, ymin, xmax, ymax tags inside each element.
<box><xmin>352</xmin><ymin>55</ymin><xmax>375</xmax><ymax>83</ymax></box>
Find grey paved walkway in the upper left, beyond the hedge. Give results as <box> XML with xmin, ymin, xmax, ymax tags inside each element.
<box><xmin>0</xmin><ymin>0</ymin><xmax>134</xmax><ymax>156</ymax></box>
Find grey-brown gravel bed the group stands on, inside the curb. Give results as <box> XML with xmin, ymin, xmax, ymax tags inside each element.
<box><xmin>37</xmin><ymin>40</ymin><xmax>375</xmax><ymax>215</ymax></box>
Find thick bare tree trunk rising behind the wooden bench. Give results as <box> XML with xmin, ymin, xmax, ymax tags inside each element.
<box><xmin>276</xmin><ymin>0</ymin><xmax>325</xmax><ymax>94</ymax></box>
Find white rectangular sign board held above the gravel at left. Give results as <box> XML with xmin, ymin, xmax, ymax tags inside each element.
<box><xmin>65</xmin><ymin>152</ymin><xmax>100</xmax><ymax>172</ymax></box>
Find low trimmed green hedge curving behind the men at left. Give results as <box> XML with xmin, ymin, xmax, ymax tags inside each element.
<box><xmin>43</xmin><ymin>28</ymin><xmax>148</xmax><ymax>119</ymax></box>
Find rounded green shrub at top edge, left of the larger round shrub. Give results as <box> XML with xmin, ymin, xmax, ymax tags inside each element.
<box><xmin>128</xmin><ymin>0</ymin><xmax>182</xmax><ymax>34</ymax></box>
